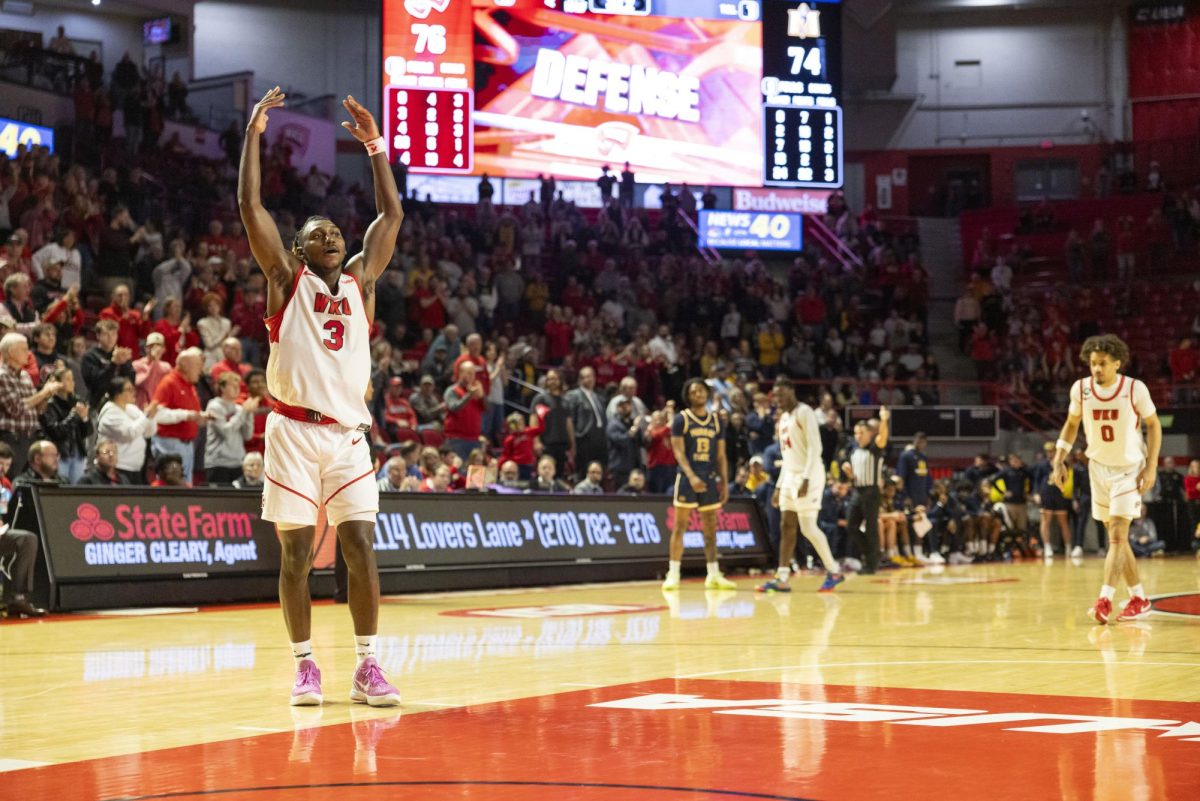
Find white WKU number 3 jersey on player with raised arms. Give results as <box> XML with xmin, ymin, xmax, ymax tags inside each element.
<box><xmin>266</xmin><ymin>266</ymin><xmax>371</xmax><ymax>428</ymax></box>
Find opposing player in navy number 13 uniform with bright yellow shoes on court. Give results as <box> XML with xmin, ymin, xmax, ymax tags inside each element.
<box><xmin>662</xmin><ymin>378</ymin><xmax>738</xmax><ymax>590</ymax></box>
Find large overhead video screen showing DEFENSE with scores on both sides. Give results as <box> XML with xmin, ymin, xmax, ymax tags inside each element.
<box><xmin>383</xmin><ymin>0</ymin><xmax>841</xmax><ymax>186</ymax></box>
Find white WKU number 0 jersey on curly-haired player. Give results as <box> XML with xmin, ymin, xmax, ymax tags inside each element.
<box><xmin>1070</xmin><ymin>375</ymin><xmax>1158</xmax><ymax>468</ymax></box>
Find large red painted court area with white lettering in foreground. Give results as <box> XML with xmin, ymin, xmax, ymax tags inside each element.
<box><xmin>11</xmin><ymin>680</ymin><xmax>1200</xmax><ymax>801</ymax></box>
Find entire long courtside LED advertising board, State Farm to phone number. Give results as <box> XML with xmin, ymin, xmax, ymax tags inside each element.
<box><xmin>37</xmin><ymin>487</ymin><xmax>767</xmax><ymax>589</ymax></box>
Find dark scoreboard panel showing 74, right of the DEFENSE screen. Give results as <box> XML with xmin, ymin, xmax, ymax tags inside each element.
<box><xmin>762</xmin><ymin>0</ymin><xmax>842</xmax><ymax>187</ymax></box>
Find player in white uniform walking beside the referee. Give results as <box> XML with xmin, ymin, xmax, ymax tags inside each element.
<box><xmin>756</xmin><ymin>378</ymin><xmax>846</xmax><ymax>592</ymax></box>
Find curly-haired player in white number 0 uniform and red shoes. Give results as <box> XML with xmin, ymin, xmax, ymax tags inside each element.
<box><xmin>1050</xmin><ymin>335</ymin><xmax>1163</xmax><ymax>625</ymax></box>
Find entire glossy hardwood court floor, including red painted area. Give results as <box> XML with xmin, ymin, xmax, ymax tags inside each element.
<box><xmin>0</xmin><ymin>558</ymin><xmax>1200</xmax><ymax>801</ymax></box>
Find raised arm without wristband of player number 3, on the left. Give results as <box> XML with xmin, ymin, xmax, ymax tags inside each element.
<box><xmin>238</xmin><ymin>86</ymin><xmax>295</xmax><ymax>287</ymax></box>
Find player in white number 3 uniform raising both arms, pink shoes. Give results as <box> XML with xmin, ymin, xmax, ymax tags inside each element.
<box><xmin>238</xmin><ymin>86</ymin><xmax>404</xmax><ymax>706</ymax></box>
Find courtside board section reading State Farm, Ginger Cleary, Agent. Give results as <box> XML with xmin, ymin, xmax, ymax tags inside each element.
<box><xmin>37</xmin><ymin>487</ymin><xmax>280</xmax><ymax>582</ymax></box>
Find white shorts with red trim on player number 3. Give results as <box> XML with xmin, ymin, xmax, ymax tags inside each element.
<box><xmin>263</xmin><ymin>414</ymin><xmax>379</xmax><ymax>526</ymax></box>
